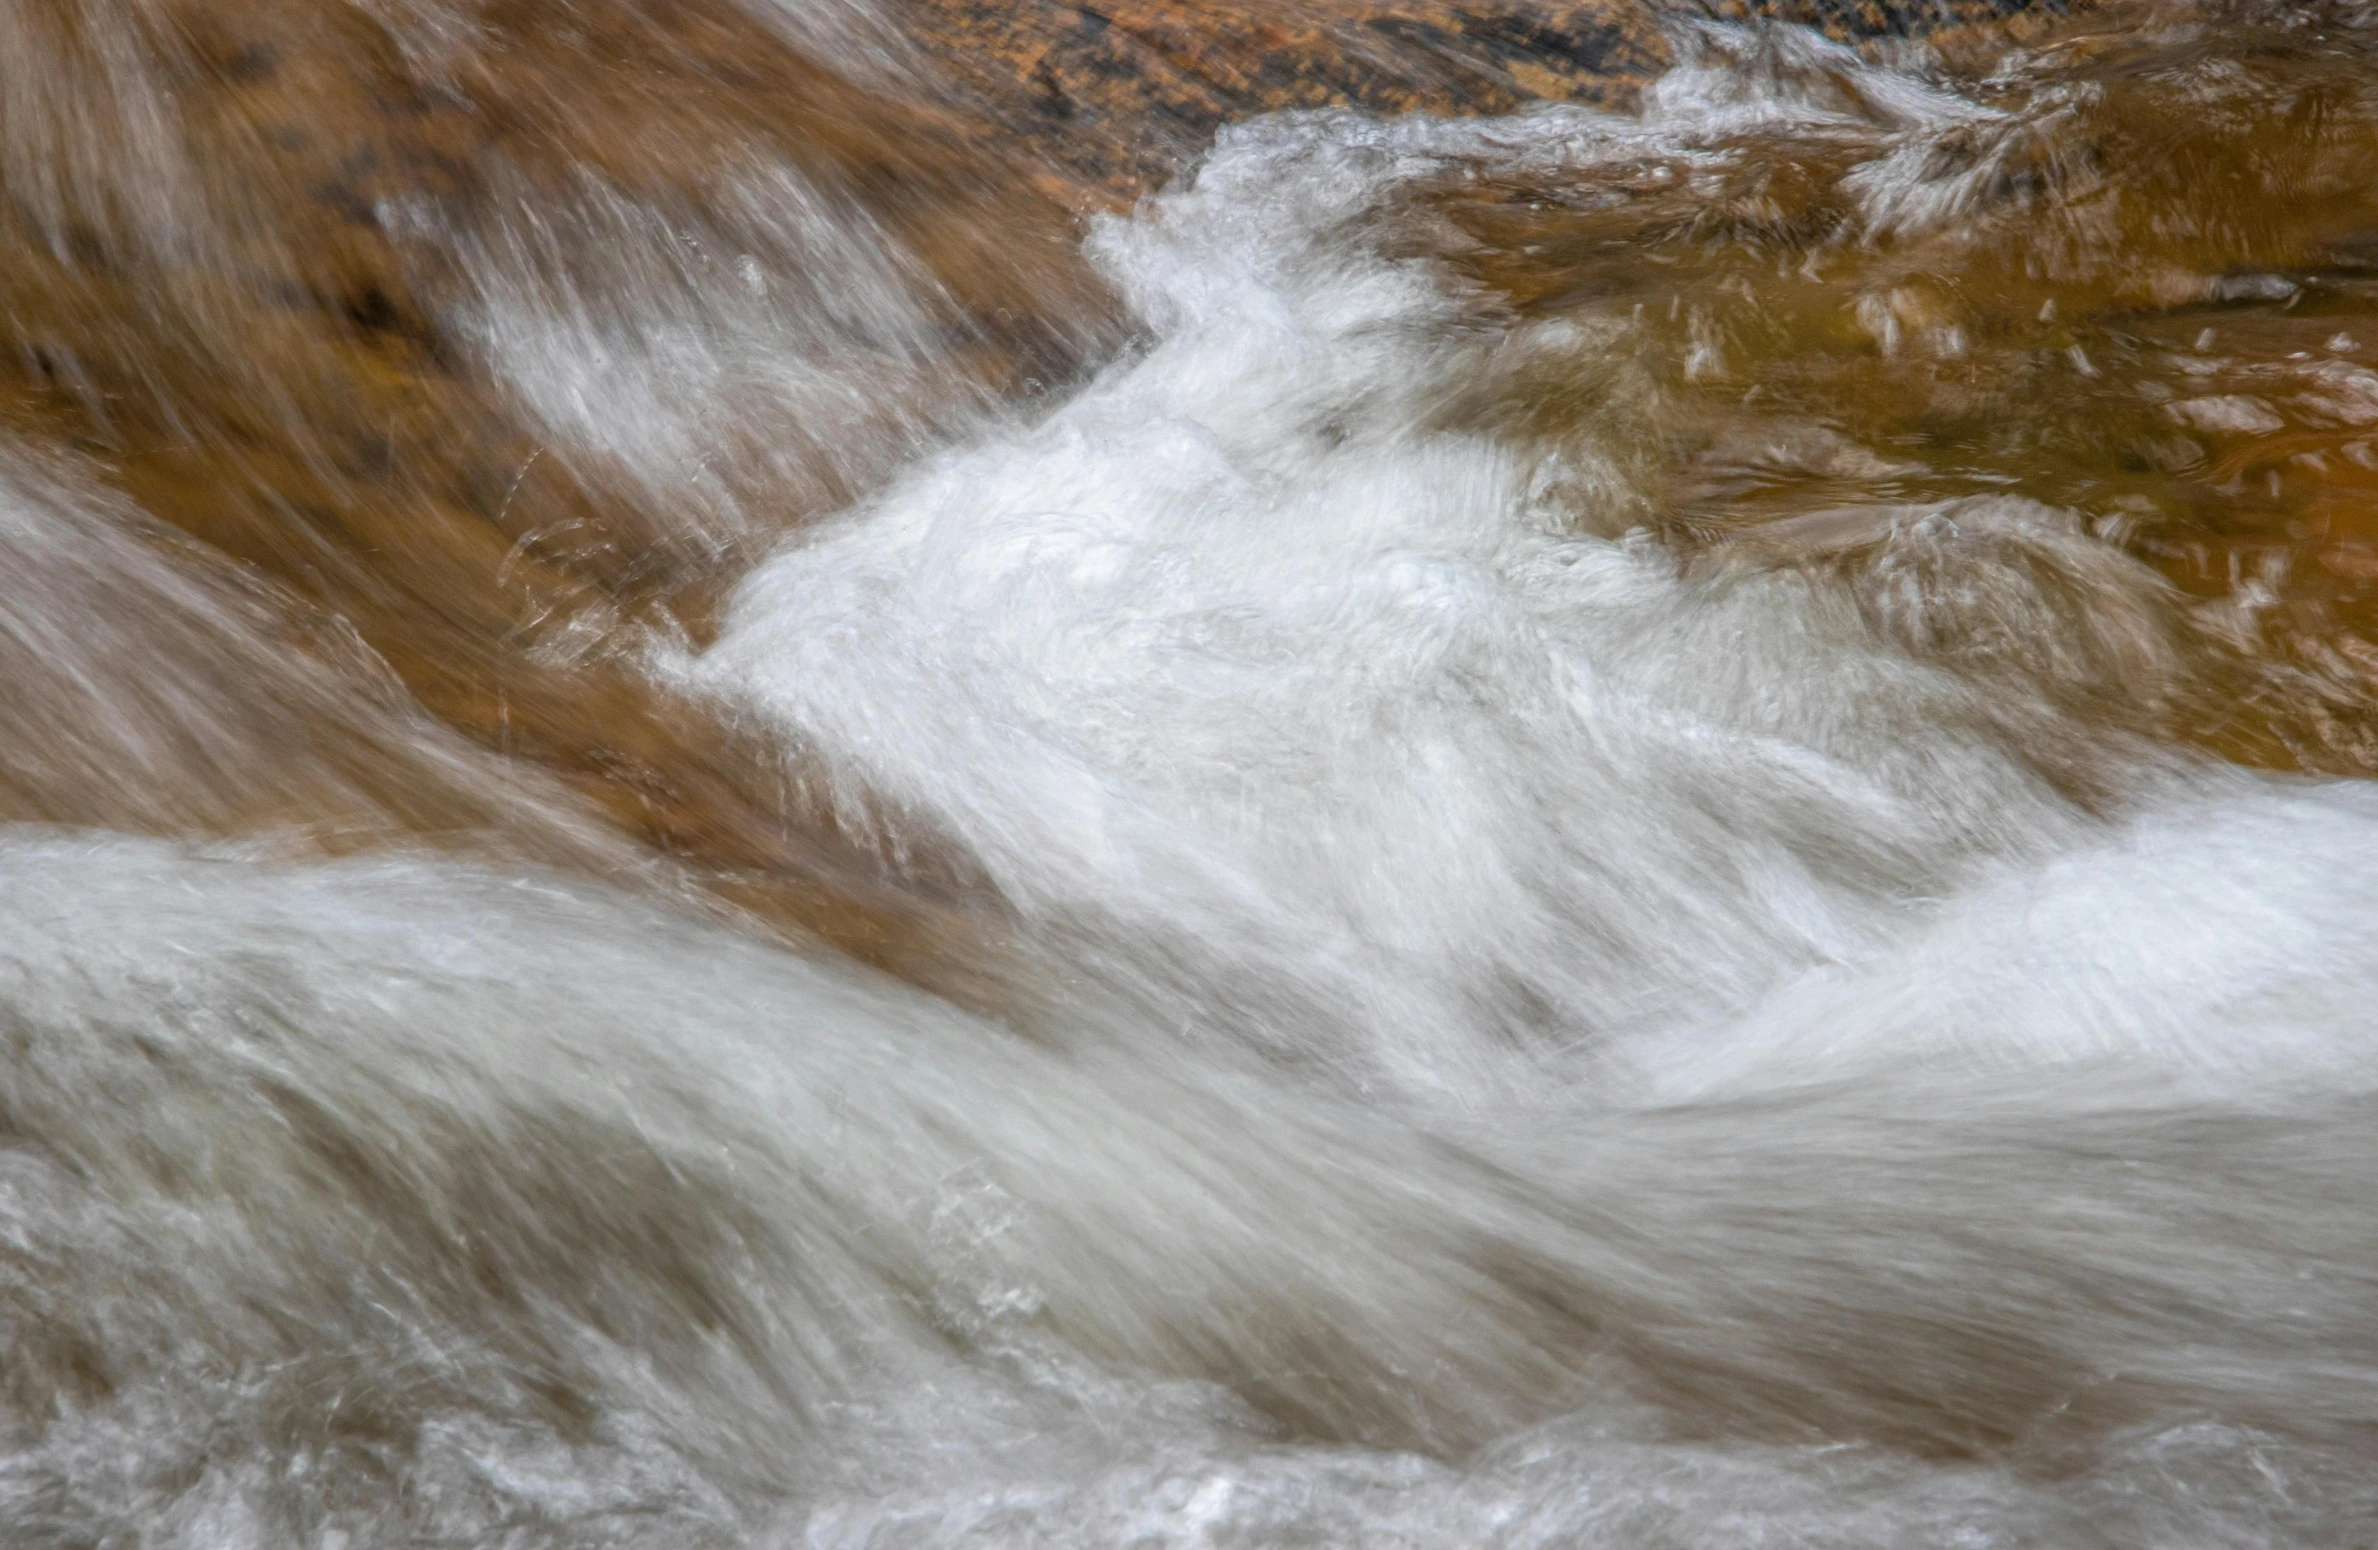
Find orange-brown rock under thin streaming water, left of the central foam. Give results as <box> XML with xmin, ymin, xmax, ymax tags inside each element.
<box><xmin>0</xmin><ymin>0</ymin><xmax>2092</xmax><ymax>958</ymax></box>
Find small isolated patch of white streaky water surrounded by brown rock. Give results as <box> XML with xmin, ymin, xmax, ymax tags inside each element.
<box><xmin>454</xmin><ymin>166</ymin><xmax>970</xmax><ymax>547</ymax></box>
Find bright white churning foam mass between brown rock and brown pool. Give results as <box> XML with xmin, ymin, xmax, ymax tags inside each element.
<box><xmin>690</xmin><ymin>87</ymin><xmax>2263</xmax><ymax>1096</ymax></box>
